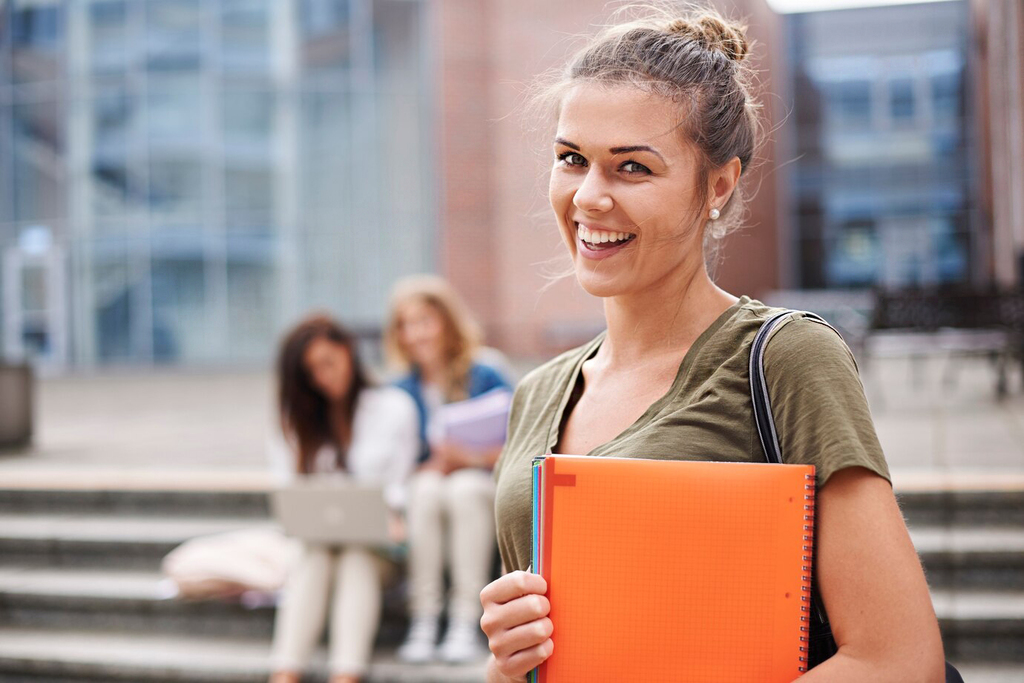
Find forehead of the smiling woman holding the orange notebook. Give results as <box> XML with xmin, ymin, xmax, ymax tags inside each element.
<box><xmin>557</xmin><ymin>83</ymin><xmax>686</xmax><ymax>154</ymax></box>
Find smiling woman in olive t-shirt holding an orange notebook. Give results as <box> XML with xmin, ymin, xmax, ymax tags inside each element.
<box><xmin>480</xmin><ymin>3</ymin><xmax>944</xmax><ymax>683</ymax></box>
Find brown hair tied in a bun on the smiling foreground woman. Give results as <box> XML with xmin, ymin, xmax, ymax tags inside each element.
<box><xmin>535</xmin><ymin>3</ymin><xmax>761</xmax><ymax>261</ymax></box>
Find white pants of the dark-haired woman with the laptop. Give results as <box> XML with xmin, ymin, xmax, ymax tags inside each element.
<box><xmin>270</xmin><ymin>544</ymin><xmax>386</xmax><ymax>676</ymax></box>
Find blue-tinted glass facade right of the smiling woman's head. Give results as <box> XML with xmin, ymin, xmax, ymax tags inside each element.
<box><xmin>786</xmin><ymin>2</ymin><xmax>978</xmax><ymax>289</ymax></box>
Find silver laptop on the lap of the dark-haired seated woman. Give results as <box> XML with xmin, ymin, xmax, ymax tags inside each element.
<box><xmin>270</xmin><ymin>480</ymin><xmax>391</xmax><ymax>546</ymax></box>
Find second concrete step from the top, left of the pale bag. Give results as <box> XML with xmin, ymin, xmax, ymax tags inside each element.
<box><xmin>0</xmin><ymin>514</ymin><xmax>268</xmax><ymax>571</ymax></box>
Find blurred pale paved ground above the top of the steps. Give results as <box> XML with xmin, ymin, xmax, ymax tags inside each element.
<box><xmin>0</xmin><ymin>358</ymin><xmax>1024</xmax><ymax>486</ymax></box>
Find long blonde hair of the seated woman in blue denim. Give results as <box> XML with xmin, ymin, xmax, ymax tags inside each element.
<box><xmin>384</xmin><ymin>275</ymin><xmax>483</xmax><ymax>400</ymax></box>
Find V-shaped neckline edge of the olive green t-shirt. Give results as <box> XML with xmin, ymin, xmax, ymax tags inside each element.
<box><xmin>545</xmin><ymin>295</ymin><xmax>752</xmax><ymax>456</ymax></box>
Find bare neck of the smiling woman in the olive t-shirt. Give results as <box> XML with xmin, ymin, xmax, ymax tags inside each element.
<box><xmin>600</xmin><ymin>264</ymin><xmax>737</xmax><ymax>367</ymax></box>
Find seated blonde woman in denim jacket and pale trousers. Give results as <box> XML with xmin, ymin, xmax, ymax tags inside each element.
<box><xmin>385</xmin><ymin>275</ymin><xmax>509</xmax><ymax>663</ymax></box>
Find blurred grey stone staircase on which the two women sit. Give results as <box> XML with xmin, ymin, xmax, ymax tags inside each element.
<box><xmin>0</xmin><ymin>485</ymin><xmax>1024</xmax><ymax>683</ymax></box>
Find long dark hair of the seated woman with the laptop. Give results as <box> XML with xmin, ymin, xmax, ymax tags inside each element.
<box><xmin>276</xmin><ymin>314</ymin><xmax>371</xmax><ymax>474</ymax></box>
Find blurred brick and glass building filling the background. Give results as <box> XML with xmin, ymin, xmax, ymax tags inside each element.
<box><xmin>0</xmin><ymin>0</ymin><xmax>1024</xmax><ymax>369</ymax></box>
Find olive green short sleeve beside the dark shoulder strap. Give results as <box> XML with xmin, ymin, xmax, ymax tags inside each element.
<box><xmin>765</xmin><ymin>319</ymin><xmax>892</xmax><ymax>487</ymax></box>
